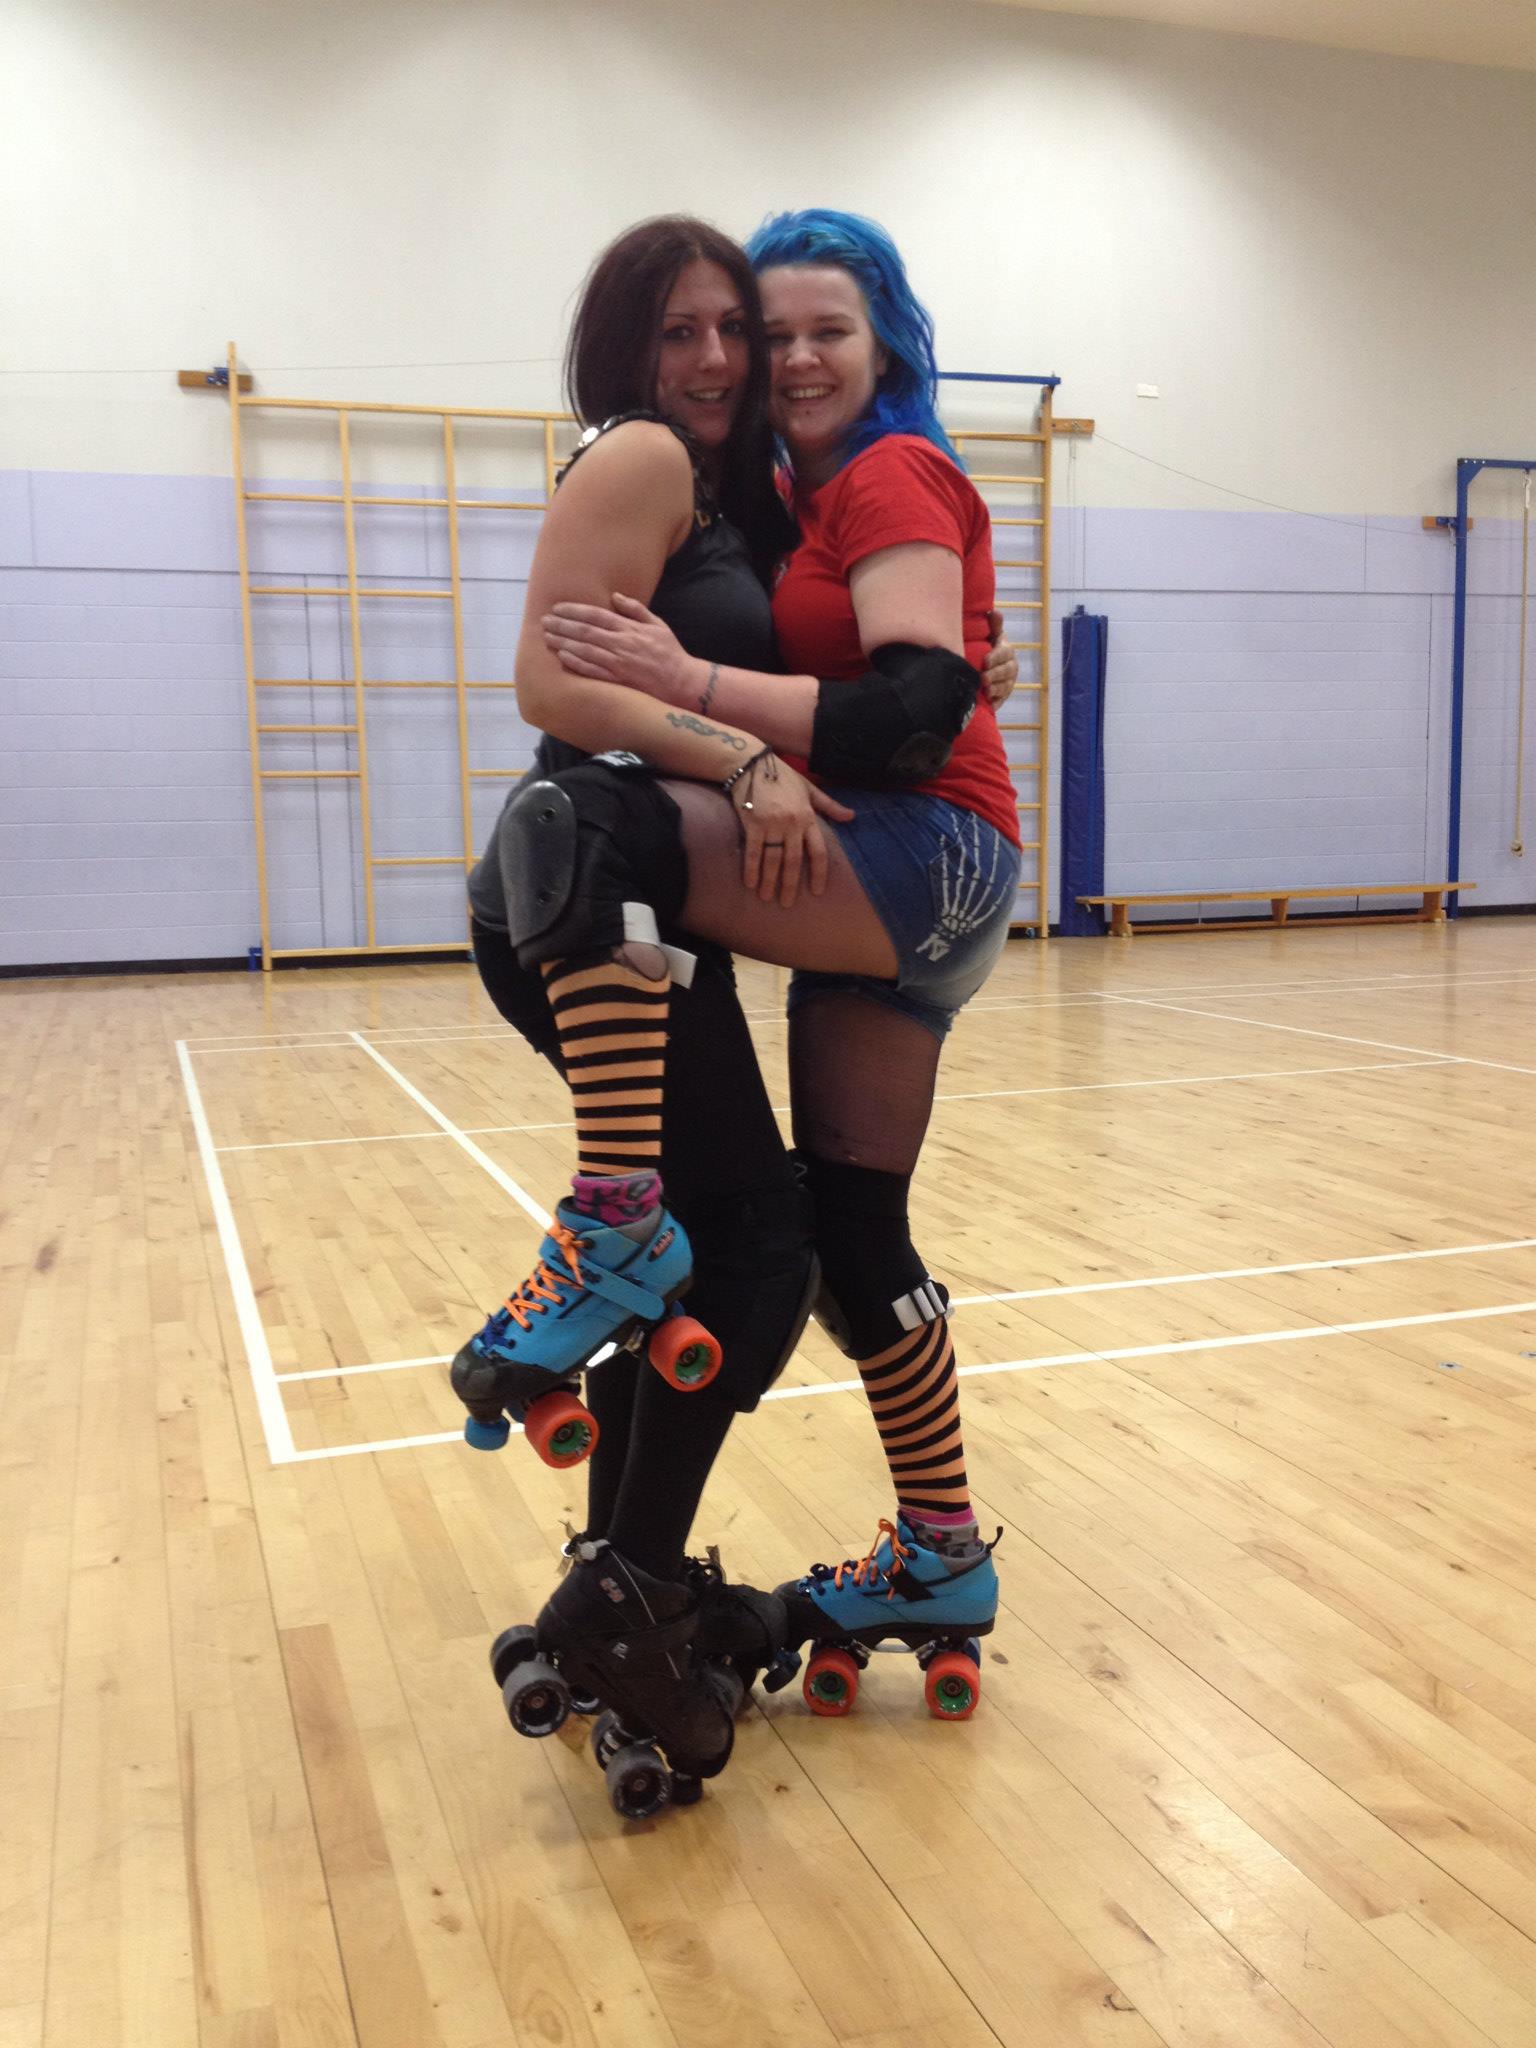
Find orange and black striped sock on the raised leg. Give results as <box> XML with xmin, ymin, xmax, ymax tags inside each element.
<box><xmin>543</xmin><ymin>961</ymin><xmax>672</xmax><ymax>1180</ymax></box>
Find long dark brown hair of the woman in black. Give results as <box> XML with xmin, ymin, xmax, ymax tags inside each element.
<box><xmin>565</xmin><ymin>213</ymin><xmax>795</xmax><ymax>580</ymax></box>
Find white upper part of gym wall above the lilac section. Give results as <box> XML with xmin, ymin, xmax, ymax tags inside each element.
<box><xmin>0</xmin><ymin>0</ymin><xmax>1536</xmax><ymax>514</ymax></box>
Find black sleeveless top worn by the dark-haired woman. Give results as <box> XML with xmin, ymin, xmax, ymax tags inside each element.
<box><xmin>469</xmin><ymin>412</ymin><xmax>778</xmax><ymax>930</ymax></box>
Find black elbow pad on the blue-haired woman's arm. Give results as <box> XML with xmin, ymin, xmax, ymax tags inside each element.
<box><xmin>811</xmin><ymin>641</ymin><xmax>981</xmax><ymax>788</ymax></box>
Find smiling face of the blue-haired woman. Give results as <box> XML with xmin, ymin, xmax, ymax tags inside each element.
<box><xmin>758</xmin><ymin>264</ymin><xmax>887</xmax><ymax>489</ymax></box>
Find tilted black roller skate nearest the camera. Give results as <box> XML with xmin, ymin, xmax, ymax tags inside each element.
<box><xmin>492</xmin><ymin>1540</ymin><xmax>743</xmax><ymax>1821</ymax></box>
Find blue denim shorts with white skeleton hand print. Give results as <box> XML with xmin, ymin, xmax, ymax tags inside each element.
<box><xmin>788</xmin><ymin>788</ymin><xmax>1020</xmax><ymax>1038</ymax></box>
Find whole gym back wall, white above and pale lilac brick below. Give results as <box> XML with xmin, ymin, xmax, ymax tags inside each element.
<box><xmin>0</xmin><ymin>0</ymin><xmax>1536</xmax><ymax>965</ymax></box>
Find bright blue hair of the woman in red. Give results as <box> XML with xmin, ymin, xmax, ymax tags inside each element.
<box><xmin>745</xmin><ymin>207</ymin><xmax>961</xmax><ymax>475</ymax></box>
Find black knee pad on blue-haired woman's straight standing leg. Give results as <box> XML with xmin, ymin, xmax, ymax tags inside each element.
<box><xmin>799</xmin><ymin>1153</ymin><xmax>950</xmax><ymax>1358</ymax></box>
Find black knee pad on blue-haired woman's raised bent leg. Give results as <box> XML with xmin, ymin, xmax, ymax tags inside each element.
<box><xmin>496</xmin><ymin>754</ymin><xmax>688</xmax><ymax>967</ymax></box>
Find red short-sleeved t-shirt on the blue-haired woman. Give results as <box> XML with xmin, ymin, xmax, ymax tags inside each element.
<box><xmin>774</xmin><ymin>434</ymin><xmax>1018</xmax><ymax>846</ymax></box>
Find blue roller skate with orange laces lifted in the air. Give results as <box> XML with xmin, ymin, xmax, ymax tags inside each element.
<box><xmin>451</xmin><ymin>1202</ymin><xmax>721</xmax><ymax>1466</ymax></box>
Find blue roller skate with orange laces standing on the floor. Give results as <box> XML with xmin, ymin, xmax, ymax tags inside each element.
<box><xmin>778</xmin><ymin>1516</ymin><xmax>1001</xmax><ymax>1720</ymax></box>
